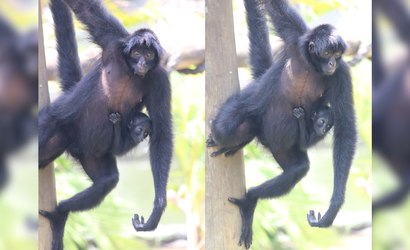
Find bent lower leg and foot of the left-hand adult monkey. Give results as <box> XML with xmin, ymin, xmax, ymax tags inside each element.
<box><xmin>40</xmin><ymin>155</ymin><xmax>118</xmax><ymax>250</ymax></box>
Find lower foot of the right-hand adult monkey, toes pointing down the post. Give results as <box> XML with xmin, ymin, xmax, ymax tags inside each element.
<box><xmin>228</xmin><ymin>198</ymin><xmax>257</xmax><ymax>249</ymax></box>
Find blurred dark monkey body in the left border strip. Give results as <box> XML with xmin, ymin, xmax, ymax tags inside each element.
<box><xmin>0</xmin><ymin>16</ymin><xmax>38</xmax><ymax>191</ymax></box>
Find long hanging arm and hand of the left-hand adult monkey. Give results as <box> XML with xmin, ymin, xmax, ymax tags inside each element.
<box><xmin>133</xmin><ymin>67</ymin><xmax>173</xmax><ymax>231</ymax></box>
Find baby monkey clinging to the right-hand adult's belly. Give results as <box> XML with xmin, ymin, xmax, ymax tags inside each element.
<box><xmin>293</xmin><ymin>100</ymin><xmax>333</xmax><ymax>149</ymax></box>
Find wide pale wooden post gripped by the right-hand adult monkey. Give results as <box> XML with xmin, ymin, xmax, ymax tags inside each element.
<box><xmin>205</xmin><ymin>0</ymin><xmax>246</xmax><ymax>250</ymax></box>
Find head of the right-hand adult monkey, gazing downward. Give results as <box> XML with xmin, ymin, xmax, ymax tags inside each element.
<box><xmin>300</xmin><ymin>24</ymin><xmax>346</xmax><ymax>76</ymax></box>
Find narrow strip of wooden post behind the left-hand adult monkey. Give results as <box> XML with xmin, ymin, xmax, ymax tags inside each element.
<box><xmin>38</xmin><ymin>1</ymin><xmax>56</xmax><ymax>250</ymax></box>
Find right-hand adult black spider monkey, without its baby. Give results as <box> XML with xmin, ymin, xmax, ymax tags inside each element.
<box><xmin>207</xmin><ymin>0</ymin><xmax>356</xmax><ymax>248</ymax></box>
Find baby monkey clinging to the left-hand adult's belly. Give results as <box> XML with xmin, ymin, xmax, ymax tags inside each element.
<box><xmin>109</xmin><ymin>112</ymin><xmax>152</xmax><ymax>155</ymax></box>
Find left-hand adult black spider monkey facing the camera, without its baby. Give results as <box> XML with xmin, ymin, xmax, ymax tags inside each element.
<box><xmin>39</xmin><ymin>0</ymin><xmax>173</xmax><ymax>249</ymax></box>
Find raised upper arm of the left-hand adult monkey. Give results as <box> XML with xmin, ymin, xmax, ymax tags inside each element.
<box><xmin>64</xmin><ymin>0</ymin><xmax>128</xmax><ymax>48</ymax></box>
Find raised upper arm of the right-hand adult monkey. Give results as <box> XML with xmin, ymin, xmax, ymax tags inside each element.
<box><xmin>266</xmin><ymin>0</ymin><xmax>308</xmax><ymax>44</ymax></box>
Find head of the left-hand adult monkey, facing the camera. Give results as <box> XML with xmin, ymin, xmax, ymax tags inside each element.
<box><xmin>123</xmin><ymin>29</ymin><xmax>164</xmax><ymax>77</ymax></box>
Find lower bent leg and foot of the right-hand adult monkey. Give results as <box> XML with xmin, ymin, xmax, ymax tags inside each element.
<box><xmin>229</xmin><ymin>149</ymin><xmax>309</xmax><ymax>248</ymax></box>
